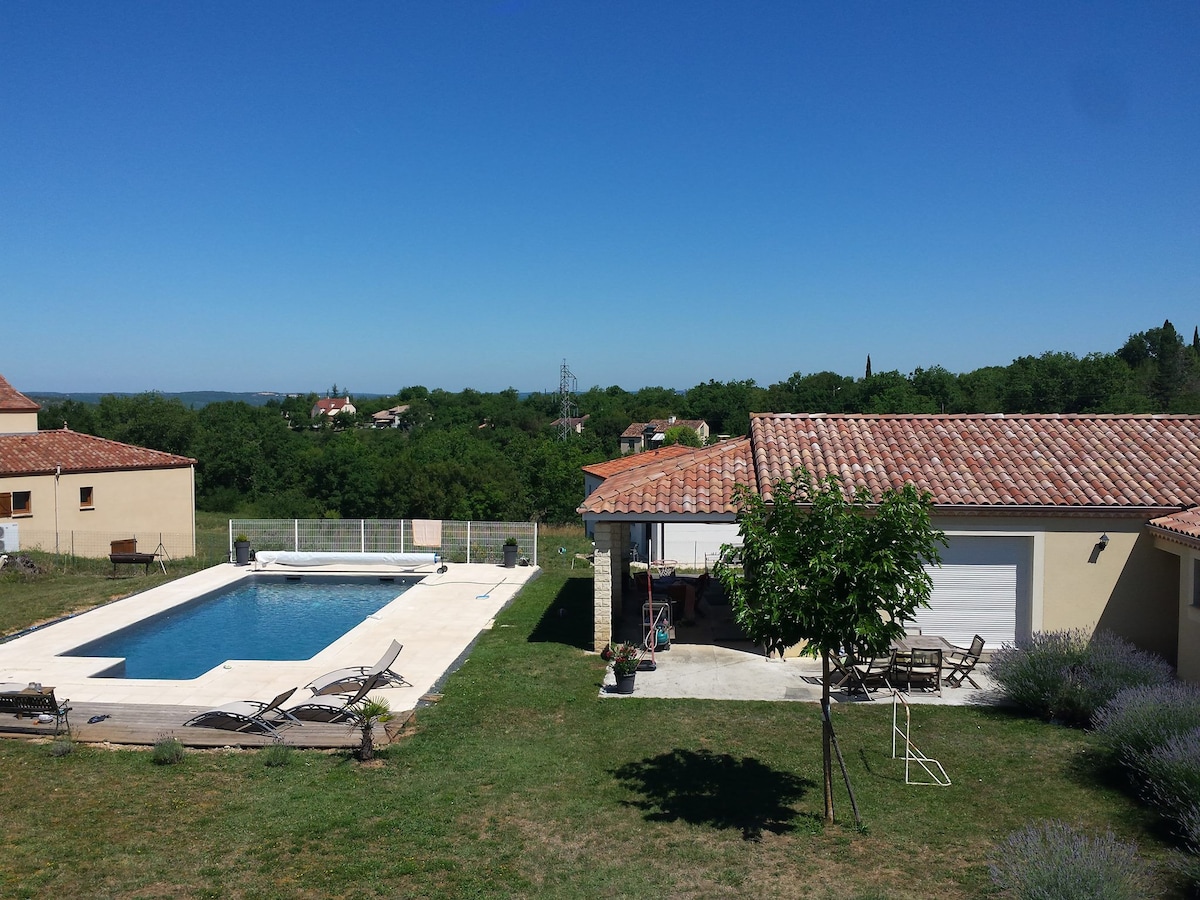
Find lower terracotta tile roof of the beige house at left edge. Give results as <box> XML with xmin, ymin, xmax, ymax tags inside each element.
<box><xmin>0</xmin><ymin>428</ymin><xmax>196</xmax><ymax>475</ymax></box>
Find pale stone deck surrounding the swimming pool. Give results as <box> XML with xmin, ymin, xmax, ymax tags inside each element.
<box><xmin>0</xmin><ymin>563</ymin><xmax>541</xmax><ymax>712</ymax></box>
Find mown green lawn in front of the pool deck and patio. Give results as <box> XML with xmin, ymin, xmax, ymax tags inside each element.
<box><xmin>0</xmin><ymin>534</ymin><xmax>1181</xmax><ymax>900</ymax></box>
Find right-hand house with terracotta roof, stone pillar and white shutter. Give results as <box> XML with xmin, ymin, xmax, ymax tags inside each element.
<box><xmin>580</xmin><ymin>413</ymin><xmax>1200</xmax><ymax>680</ymax></box>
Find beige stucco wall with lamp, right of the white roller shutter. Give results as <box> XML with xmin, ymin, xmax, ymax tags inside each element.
<box><xmin>934</xmin><ymin>516</ymin><xmax>1178</xmax><ymax>661</ymax></box>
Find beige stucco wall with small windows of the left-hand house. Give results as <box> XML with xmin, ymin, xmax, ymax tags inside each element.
<box><xmin>0</xmin><ymin>467</ymin><xmax>196</xmax><ymax>557</ymax></box>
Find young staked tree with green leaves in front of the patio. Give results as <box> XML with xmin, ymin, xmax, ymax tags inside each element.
<box><xmin>715</xmin><ymin>469</ymin><xmax>946</xmax><ymax>823</ymax></box>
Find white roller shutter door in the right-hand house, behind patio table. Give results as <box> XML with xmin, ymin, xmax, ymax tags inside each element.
<box><xmin>917</xmin><ymin>535</ymin><xmax>1033</xmax><ymax>648</ymax></box>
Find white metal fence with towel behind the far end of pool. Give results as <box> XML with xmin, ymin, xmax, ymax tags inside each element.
<box><xmin>229</xmin><ymin>518</ymin><xmax>538</xmax><ymax>565</ymax></box>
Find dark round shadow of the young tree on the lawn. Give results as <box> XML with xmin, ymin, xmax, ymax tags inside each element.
<box><xmin>613</xmin><ymin>749</ymin><xmax>815</xmax><ymax>841</ymax></box>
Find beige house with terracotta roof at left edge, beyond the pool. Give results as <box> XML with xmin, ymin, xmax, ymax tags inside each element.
<box><xmin>0</xmin><ymin>378</ymin><xmax>196</xmax><ymax>557</ymax></box>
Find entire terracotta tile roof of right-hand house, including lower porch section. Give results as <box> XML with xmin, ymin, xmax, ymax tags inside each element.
<box><xmin>580</xmin><ymin>413</ymin><xmax>1200</xmax><ymax>518</ymax></box>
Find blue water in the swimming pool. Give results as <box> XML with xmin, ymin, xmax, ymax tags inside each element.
<box><xmin>62</xmin><ymin>575</ymin><xmax>420</xmax><ymax>678</ymax></box>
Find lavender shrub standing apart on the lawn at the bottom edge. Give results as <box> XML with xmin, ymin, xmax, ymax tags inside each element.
<box><xmin>989</xmin><ymin>822</ymin><xmax>1146</xmax><ymax>900</ymax></box>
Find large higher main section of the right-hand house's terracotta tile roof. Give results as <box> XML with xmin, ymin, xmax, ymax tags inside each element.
<box><xmin>750</xmin><ymin>413</ymin><xmax>1200</xmax><ymax>508</ymax></box>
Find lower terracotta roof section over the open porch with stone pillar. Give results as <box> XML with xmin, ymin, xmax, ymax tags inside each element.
<box><xmin>578</xmin><ymin>438</ymin><xmax>754</xmax><ymax>515</ymax></box>
